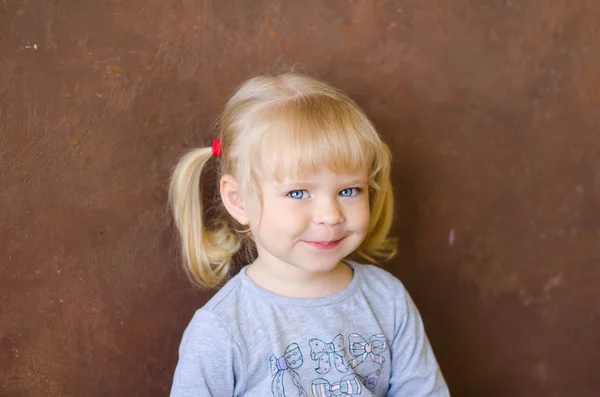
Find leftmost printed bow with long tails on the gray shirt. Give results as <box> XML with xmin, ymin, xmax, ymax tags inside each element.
<box><xmin>269</xmin><ymin>343</ymin><xmax>307</xmax><ymax>397</ymax></box>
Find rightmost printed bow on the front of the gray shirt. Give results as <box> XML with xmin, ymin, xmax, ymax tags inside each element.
<box><xmin>348</xmin><ymin>333</ymin><xmax>387</xmax><ymax>390</ymax></box>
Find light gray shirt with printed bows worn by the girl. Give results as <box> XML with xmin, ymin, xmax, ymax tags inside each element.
<box><xmin>171</xmin><ymin>262</ymin><xmax>450</xmax><ymax>397</ymax></box>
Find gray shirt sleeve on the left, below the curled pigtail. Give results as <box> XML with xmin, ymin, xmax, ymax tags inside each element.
<box><xmin>170</xmin><ymin>309</ymin><xmax>244</xmax><ymax>397</ymax></box>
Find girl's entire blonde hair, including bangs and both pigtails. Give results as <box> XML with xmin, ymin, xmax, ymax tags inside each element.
<box><xmin>169</xmin><ymin>73</ymin><xmax>396</xmax><ymax>288</ymax></box>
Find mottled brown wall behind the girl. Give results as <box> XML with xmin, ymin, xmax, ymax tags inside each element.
<box><xmin>0</xmin><ymin>0</ymin><xmax>600</xmax><ymax>397</ymax></box>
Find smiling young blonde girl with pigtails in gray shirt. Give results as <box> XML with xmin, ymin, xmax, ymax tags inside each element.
<box><xmin>170</xmin><ymin>74</ymin><xmax>449</xmax><ymax>397</ymax></box>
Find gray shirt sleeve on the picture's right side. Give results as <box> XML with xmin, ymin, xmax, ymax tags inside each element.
<box><xmin>387</xmin><ymin>289</ymin><xmax>450</xmax><ymax>397</ymax></box>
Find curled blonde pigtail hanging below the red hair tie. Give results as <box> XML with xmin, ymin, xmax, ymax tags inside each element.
<box><xmin>169</xmin><ymin>147</ymin><xmax>240</xmax><ymax>288</ymax></box>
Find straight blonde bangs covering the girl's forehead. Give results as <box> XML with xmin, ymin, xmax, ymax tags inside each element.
<box><xmin>248</xmin><ymin>96</ymin><xmax>384</xmax><ymax>181</ymax></box>
